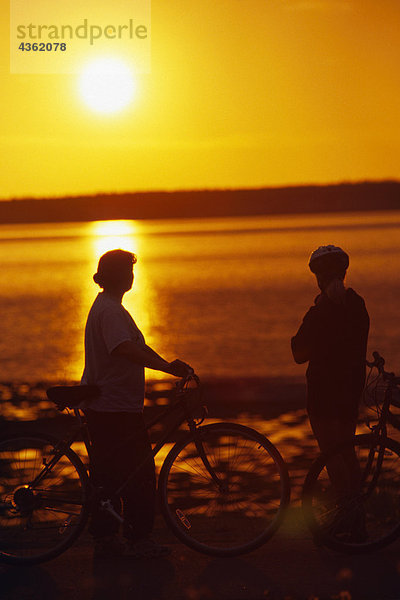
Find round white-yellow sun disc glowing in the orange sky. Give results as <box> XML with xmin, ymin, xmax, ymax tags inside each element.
<box><xmin>79</xmin><ymin>58</ymin><xmax>136</xmax><ymax>114</ymax></box>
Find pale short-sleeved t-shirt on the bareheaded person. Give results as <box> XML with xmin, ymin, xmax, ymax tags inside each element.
<box><xmin>81</xmin><ymin>292</ymin><xmax>145</xmax><ymax>413</ymax></box>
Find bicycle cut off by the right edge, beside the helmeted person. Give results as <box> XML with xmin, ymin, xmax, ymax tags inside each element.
<box><xmin>302</xmin><ymin>352</ymin><xmax>400</xmax><ymax>554</ymax></box>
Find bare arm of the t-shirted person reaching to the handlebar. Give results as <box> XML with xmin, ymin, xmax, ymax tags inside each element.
<box><xmin>111</xmin><ymin>340</ymin><xmax>191</xmax><ymax>377</ymax></box>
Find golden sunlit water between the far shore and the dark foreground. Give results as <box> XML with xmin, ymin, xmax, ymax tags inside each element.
<box><xmin>0</xmin><ymin>211</ymin><xmax>400</xmax><ymax>382</ymax></box>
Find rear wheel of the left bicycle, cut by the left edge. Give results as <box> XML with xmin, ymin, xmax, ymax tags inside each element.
<box><xmin>0</xmin><ymin>434</ymin><xmax>89</xmax><ymax>565</ymax></box>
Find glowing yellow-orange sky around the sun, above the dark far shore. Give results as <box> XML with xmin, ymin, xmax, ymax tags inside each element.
<box><xmin>0</xmin><ymin>0</ymin><xmax>400</xmax><ymax>198</ymax></box>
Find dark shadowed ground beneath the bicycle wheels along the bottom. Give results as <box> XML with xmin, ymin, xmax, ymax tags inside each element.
<box><xmin>0</xmin><ymin>508</ymin><xmax>400</xmax><ymax>600</ymax></box>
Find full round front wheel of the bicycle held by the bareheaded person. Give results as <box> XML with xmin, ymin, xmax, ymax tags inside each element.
<box><xmin>159</xmin><ymin>423</ymin><xmax>290</xmax><ymax>556</ymax></box>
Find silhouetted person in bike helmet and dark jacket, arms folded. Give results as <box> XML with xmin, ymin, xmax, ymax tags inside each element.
<box><xmin>292</xmin><ymin>245</ymin><xmax>369</xmax><ymax>540</ymax></box>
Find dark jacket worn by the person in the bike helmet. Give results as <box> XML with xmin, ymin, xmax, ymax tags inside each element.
<box><xmin>292</xmin><ymin>288</ymin><xmax>369</xmax><ymax>417</ymax></box>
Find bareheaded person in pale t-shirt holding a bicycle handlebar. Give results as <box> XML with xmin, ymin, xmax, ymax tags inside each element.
<box><xmin>82</xmin><ymin>250</ymin><xmax>190</xmax><ymax>557</ymax></box>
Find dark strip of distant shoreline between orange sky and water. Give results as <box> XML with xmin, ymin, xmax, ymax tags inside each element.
<box><xmin>0</xmin><ymin>181</ymin><xmax>400</xmax><ymax>224</ymax></box>
